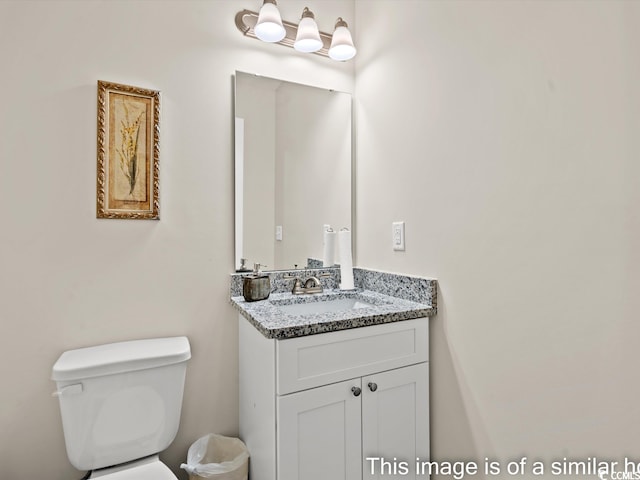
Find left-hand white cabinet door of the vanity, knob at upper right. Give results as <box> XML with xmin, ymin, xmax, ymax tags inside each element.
<box><xmin>277</xmin><ymin>378</ymin><xmax>362</xmax><ymax>480</ymax></box>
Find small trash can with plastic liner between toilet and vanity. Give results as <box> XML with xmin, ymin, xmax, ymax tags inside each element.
<box><xmin>180</xmin><ymin>433</ymin><xmax>249</xmax><ymax>478</ymax></box>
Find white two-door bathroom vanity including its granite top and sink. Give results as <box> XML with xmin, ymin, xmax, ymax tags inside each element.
<box><xmin>232</xmin><ymin>269</ymin><xmax>435</xmax><ymax>480</ymax></box>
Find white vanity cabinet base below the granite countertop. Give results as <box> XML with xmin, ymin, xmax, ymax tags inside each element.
<box><xmin>239</xmin><ymin>317</ymin><xmax>429</xmax><ymax>480</ymax></box>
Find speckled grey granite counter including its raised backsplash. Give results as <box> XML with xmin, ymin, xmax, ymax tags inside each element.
<box><xmin>231</xmin><ymin>268</ymin><xmax>437</xmax><ymax>339</ymax></box>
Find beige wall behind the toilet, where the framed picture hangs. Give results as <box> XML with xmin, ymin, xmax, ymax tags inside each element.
<box><xmin>0</xmin><ymin>0</ymin><xmax>354</xmax><ymax>480</ymax></box>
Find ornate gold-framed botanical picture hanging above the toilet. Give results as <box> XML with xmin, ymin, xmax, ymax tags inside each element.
<box><xmin>97</xmin><ymin>80</ymin><xmax>160</xmax><ymax>220</ymax></box>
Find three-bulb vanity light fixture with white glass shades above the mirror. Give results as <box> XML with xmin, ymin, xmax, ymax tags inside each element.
<box><xmin>235</xmin><ymin>0</ymin><xmax>356</xmax><ymax>61</ymax></box>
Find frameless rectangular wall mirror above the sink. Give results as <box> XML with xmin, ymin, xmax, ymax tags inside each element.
<box><xmin>235</xmin><ymin>72</ymin><xmax>352</xmax><ymax>270</ymax></box>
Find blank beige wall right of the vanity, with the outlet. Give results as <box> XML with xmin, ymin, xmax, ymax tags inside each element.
<box><xmin>356</xmin><ymin>0</ymin><xmax>640</xmax><ymax>478</ymax></box>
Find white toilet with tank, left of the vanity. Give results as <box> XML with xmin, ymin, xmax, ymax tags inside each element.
<box><xmin>52</xmin><ymin>337</ymin><xmax>191</xmax><ymax>480</ymax></box>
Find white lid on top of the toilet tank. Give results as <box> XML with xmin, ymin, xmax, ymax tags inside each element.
<box><xmin>51</xmin><ymin>337</ymin><xmax>191</xmax><ymax>381</ymax></box>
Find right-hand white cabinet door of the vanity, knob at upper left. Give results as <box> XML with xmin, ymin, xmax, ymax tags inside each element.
<box><xmin>362</xmin><ymin>362</ymin><xmax>429</xmax><ymax>480</ymax></box>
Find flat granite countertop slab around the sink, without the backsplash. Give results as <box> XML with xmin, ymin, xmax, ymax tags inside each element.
<box><xmin>231</xmin><ymin>288</ymin><xmax>436</xmax><ymax>339</ymax></box>
